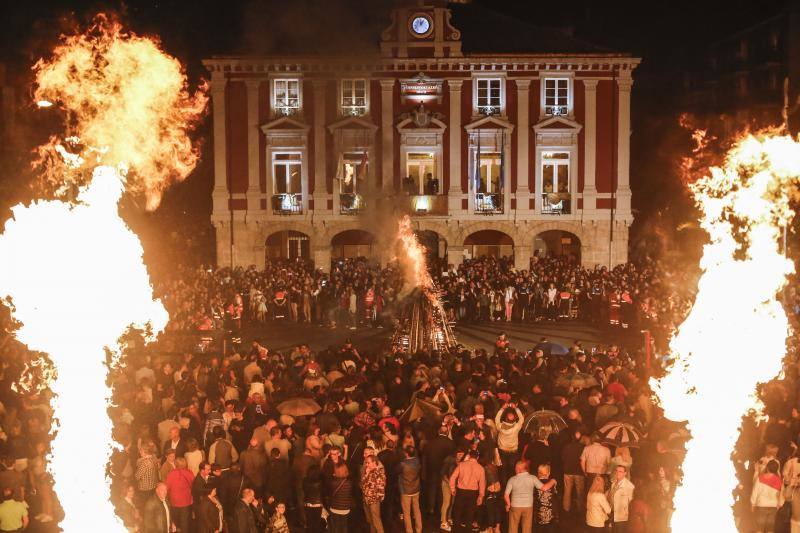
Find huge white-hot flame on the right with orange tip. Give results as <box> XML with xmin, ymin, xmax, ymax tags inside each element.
<box><xmin>652</xmin><ymin>134</ymin><xmax>800</xmax><ymax>533</ymax></box>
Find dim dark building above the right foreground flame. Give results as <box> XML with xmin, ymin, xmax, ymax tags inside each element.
<box><xmin>684</xmin><ymin>1</ymin><xmax>800</xmax><ymax>135</ymax></box>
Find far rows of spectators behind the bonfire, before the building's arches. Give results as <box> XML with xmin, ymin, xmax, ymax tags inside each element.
<box><xmin>159</xmin><ymin>257</ymin><xmax>688</xmax><ymax>352</ymax></box>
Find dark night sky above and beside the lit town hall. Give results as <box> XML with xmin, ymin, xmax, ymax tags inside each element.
<box><xmin>0</xmin><ymin>0</ymin><xmax>792</xmax><ymax>262</ymax></box>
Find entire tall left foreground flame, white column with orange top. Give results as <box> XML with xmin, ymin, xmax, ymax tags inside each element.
<box><xmin>0</xmin><ymin>14</ymin><xmax>205</xmax><ymax>533</ymax></box>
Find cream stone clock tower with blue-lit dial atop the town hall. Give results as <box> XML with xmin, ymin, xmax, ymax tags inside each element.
<box><xmin>381</xmin><ymin>0</ymin><xmax>463</xmax><ymax>58</ymax></box>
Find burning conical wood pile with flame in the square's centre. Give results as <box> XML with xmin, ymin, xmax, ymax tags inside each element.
<box><xmin>392</xmin><ymin>216</ymin><xmax>456</xmax><ymax>353</ymax></box>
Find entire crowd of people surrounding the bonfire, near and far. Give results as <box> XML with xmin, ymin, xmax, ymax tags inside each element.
<box><xmin>0</xmin><ymin>255</ymin><xmax>800</xmax><ymax>533</ymax></box>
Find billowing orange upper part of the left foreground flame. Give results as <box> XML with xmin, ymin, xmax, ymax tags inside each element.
<box><xmin>34</xmin><ymin>15</ymin><xmax>207</xmax><ymax>210</ymax></box>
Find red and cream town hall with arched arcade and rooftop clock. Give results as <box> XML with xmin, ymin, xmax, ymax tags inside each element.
<box><xmin>204</xmin><ymin>0</ymin><xmax>640</xmax><ymax>269</ymax></box>
